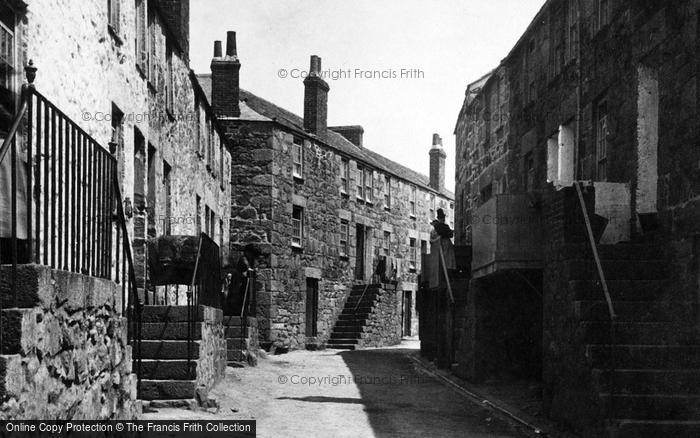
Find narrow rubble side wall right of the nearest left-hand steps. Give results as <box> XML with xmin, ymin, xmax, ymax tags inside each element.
<box><xmin>197</xmin><ymin>306</ymin><xmax>226</xmax><ymax>399</ymax></box>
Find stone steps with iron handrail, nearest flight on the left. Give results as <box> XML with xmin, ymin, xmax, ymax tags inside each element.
<box><xmin>134</xmin><ymin>306</ymin><xmax>203</xmax><ymax>407</ymax></box>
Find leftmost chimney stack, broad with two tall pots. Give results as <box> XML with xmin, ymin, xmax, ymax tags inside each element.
<box><xmin>211</xmin><ymin>32</ymin><xmax>241</xmax><ymax>117</ymax></box>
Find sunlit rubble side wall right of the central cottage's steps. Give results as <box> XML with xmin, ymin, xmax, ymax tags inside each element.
<box><xmin>357</xmin><ymin>286</ymin><xmax>402</xmax><ymax>348</ymax></box>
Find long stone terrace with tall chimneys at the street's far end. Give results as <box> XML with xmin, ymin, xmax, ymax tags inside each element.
<box><xmin>199</xmin><ymin>32</ymin><xmax>453</xmax><ymax>349</ymax></box>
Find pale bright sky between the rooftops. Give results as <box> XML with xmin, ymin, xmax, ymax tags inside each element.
<box><xmin>190</xmin><ymin>0</ymin><xmax>544</xmax><ymax>190</ymax></box>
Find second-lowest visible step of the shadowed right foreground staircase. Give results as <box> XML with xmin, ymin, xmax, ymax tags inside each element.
<box><xmin>600</xmin><ymin>393</ymin><xmax>700</xmax><ymax>421</ymax></box>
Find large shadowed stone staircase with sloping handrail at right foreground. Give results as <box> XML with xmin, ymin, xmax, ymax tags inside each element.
<box><xmin>567</xmin><ymin>243</ymin><xmax>700</xmax><ymax>438</ymax></box>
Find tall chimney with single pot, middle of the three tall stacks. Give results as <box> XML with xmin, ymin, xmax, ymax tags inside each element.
<box><xmin>304</xmin><ymin>55</ymin><xmax>330</xmax><ymax>135</ymax></box>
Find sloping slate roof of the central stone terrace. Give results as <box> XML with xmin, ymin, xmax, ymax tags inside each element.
<box><xmin>197</xmin><ymin>74</ymin><xmax>454</xmax><ymax>200</ymax></box>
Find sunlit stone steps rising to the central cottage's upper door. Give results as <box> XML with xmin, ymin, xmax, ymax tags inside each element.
<box><xmin>326</xmin><ymin>284</ymin><xmax>381</xmax><ymax>350</ymax></box>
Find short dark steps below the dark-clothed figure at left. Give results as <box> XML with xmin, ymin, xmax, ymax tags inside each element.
<box><xmin>224</xmin><ymin>316</ymin><xmax>260</xmax><ymax>368</ymax></box>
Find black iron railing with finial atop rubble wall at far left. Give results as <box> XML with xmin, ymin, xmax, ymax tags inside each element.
<box><xmin>0</xmin><ymin>66</ymin><xmax>141</xmax><ymax>386</ymax></box>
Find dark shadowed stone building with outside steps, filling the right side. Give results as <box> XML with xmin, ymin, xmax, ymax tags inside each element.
<box><xmin>438</xmin><ymin>0</ymin><xmax>700</xmax><ymax>437</ymax></box>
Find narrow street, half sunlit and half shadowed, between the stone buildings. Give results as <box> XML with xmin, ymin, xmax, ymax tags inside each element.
<box><xmin>144</xmin><ymin>340</ymin><xmax>531</xmax><ymax>438</ymax></box>
